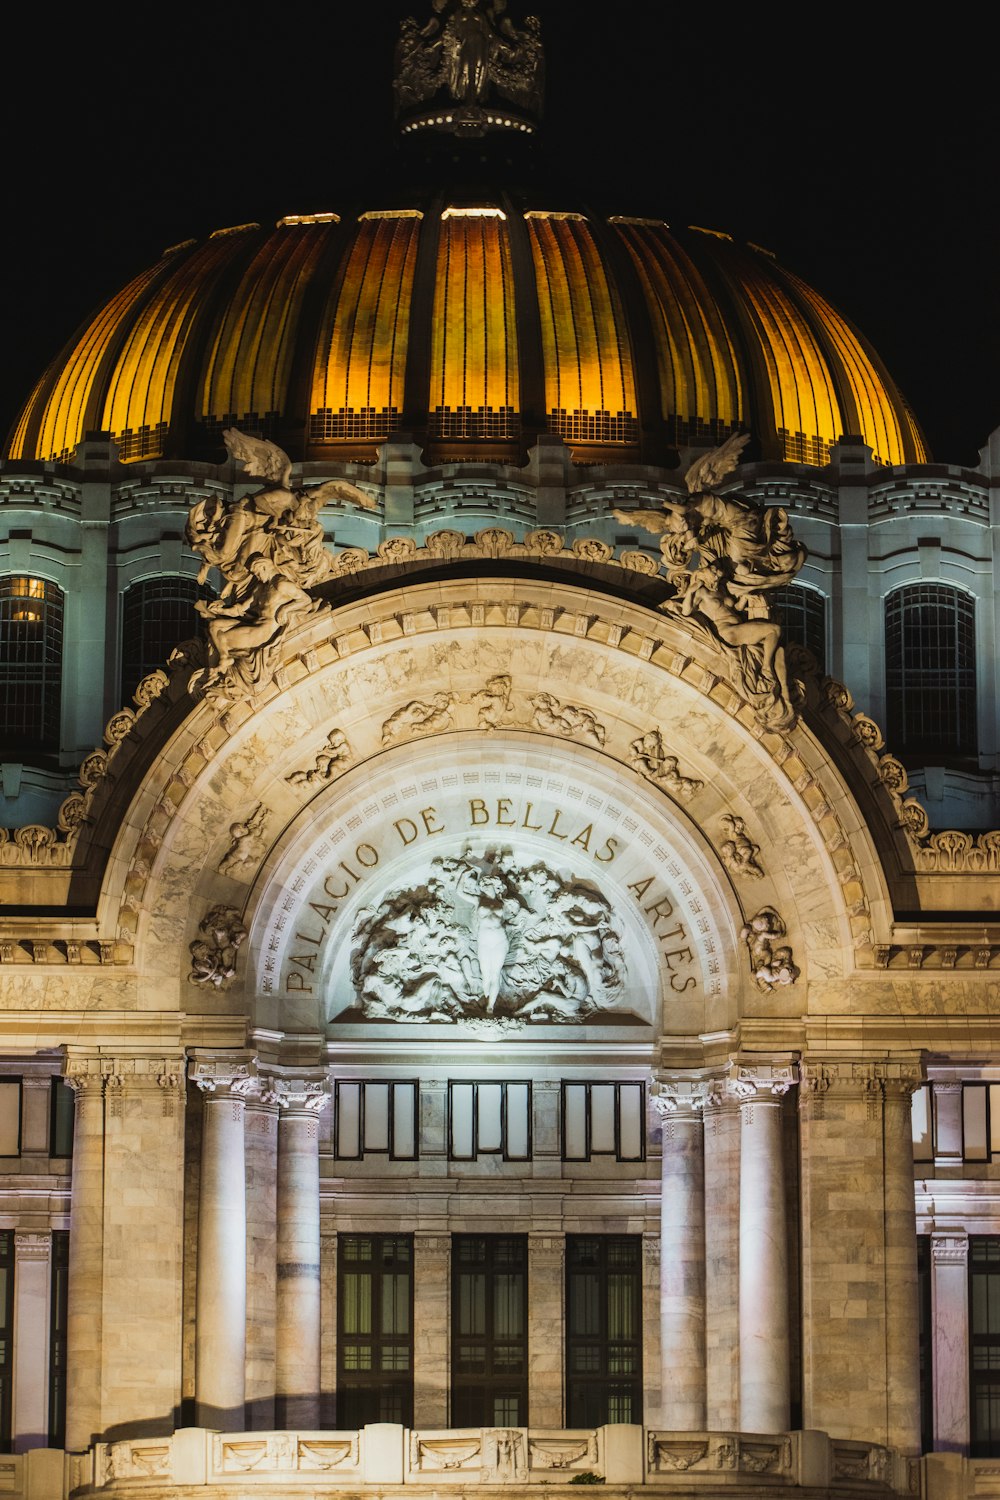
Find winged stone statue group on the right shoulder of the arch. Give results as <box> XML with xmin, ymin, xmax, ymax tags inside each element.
<box><xmin>615</xmin><ymin>434</ymin><xmax>805</xmax><ymax>729</ymax></box>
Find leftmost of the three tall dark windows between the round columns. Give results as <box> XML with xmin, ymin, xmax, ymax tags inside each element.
<box><xmin>337</xmin><ymin>1235</ymin><xmax>414</xmax><ymax>1428</ymax></box>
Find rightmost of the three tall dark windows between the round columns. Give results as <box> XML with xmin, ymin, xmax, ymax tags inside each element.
<box><xmin>567</xmin><ymin>1235</ymin><xmax>642</xmax><ymax>1427</ymax></box>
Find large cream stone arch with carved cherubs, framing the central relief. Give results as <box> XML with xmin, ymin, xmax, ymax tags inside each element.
<box><xmin>89</xmin><ymin>567</ymin><xmax>889</xmax><ymax>1035</ymax></box>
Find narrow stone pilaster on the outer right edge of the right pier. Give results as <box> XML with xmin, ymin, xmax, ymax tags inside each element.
<box><xmin>882</xmin><ymin>1067</ymin><xmax>921</xmax><ymax>1454</ymax></box>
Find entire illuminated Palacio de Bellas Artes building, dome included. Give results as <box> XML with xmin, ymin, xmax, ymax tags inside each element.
<box><xmin>0</xmin><ymin>0</ymin><xmax>1000</xmax><ymax>1500</ymax></box>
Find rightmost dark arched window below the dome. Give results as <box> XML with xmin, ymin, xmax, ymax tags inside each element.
<box><xmin>886</xmin><ymin>584</ymin><xmax>976</xmax><ymax>758</ymax></box>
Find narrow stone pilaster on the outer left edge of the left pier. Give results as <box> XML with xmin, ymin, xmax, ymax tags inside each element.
<box><xmin>66</xmin><ymin>1058</ymin><xmax>103</xmax><ymax>1452</ymax></box>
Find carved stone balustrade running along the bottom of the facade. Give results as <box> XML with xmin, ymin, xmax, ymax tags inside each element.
<box><xmin>0</xmin><ymin>1422</ymin><xmax>935</xmax><ymax>1500</ymax></box>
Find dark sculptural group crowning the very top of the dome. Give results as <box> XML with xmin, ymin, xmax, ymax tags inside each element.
<box><xmin>393</xmin><ymin>0</ymin><xmax>544</xmax><ymax>117</ymax></box>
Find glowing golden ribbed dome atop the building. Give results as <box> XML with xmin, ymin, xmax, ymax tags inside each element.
<box><xmin>6</xmin><ymin>198</ymin><xmax>927</xmax><ymax>465</ymax></box>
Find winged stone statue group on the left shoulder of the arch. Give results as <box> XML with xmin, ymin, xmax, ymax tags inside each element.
<box><xmin>186</xmin><ymin>428</ymin><xmax>375</xmax><ymax>699</ymax></box>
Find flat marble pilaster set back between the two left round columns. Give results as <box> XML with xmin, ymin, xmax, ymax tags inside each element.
<box><xmin>244</xmin><ymin>1089</ymin><xmax>277</xmax><ymax>1433</ymax></box>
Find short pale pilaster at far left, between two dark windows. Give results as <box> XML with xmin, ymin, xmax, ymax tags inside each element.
<box><xmin>12</xmin><ymin>1230</ymin><xmax>52</xmax><ymax>1454</ymax></box>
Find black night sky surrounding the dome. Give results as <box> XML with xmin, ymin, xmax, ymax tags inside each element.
<box><xmin>0</xmin><ymin>0</ymin><xmax>1000</xmax><ymax>465</ymax></box>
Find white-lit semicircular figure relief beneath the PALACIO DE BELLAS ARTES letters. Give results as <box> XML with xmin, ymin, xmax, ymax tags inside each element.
<box><xmin>351</xmin><ymin>848</ymin><xmax>627</xmax><ymax>1022</ymax></box>
